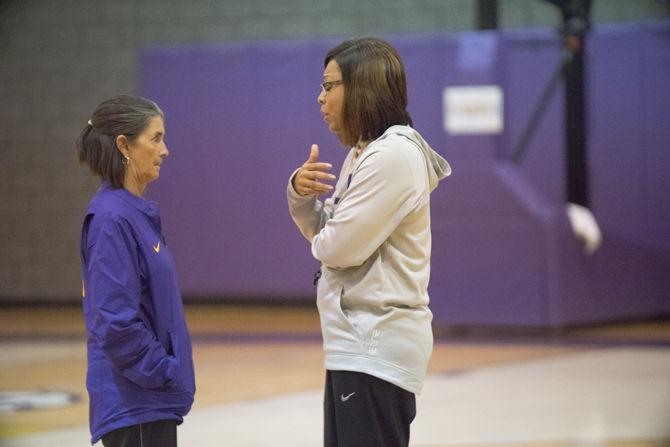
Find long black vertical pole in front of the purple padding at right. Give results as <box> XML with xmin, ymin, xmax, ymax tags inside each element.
<box><xmin>563</xmin><ymin>0</ymin><xmax>591</xmax><ymax>207</ymax></box>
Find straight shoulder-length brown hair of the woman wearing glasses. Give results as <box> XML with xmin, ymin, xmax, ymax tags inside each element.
<box><xmin>324</xmin><ymin>37</ymin><xmax>412</xmax><ymax>146</ymax></box>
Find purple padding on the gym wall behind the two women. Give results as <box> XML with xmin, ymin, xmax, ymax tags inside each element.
<box><xmin>141</xmin><ymin>21</ymin><xmax>670</xmax><ymax>326</ymax></box>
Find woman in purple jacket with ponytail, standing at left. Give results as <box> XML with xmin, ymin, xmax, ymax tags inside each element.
<box><xmin>77</xmin><ymin>95</ymin><xmax>195</xmax><ymax>447</ymax></box>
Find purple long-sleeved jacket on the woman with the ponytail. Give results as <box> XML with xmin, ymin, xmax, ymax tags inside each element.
<box><xmin>81</xmin><ymin>183</ymin><xmax>195</xmax><ymax>444</ymax></box>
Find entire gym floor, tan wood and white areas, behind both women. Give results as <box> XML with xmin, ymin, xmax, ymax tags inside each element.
<box><xmin>0</xmin><ymin>305</ymin><xmax>670</xmax><ymax>447</ymax></box>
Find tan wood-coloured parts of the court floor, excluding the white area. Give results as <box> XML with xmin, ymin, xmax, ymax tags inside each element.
<box><xmin>0</xmin><ymin>305</ymin><xmax>670</xmax><ymax>447</ymax></box>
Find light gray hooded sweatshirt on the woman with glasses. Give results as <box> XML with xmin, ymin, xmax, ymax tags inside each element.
<box><xmin>287</xmin><ymin>126</ymin><xmax>451</xmax><ymax>394</ymax></box>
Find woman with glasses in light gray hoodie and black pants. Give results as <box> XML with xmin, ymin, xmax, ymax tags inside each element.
<box><xmin>287</xmin><ymin>37</ymin><xmax>451</xmax><ymax>447</ymax></box>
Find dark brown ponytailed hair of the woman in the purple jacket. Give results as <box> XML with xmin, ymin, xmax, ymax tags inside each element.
<box><xmin>76</xmin><ymin>95</ymin><xmax>163</xmax><ymax>188</ymax></box>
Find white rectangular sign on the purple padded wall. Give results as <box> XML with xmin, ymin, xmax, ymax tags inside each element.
<box><xmin>442</xmin><ymin>85</ymin><xmax>503</xmax><ymax>135</ymax></box>
